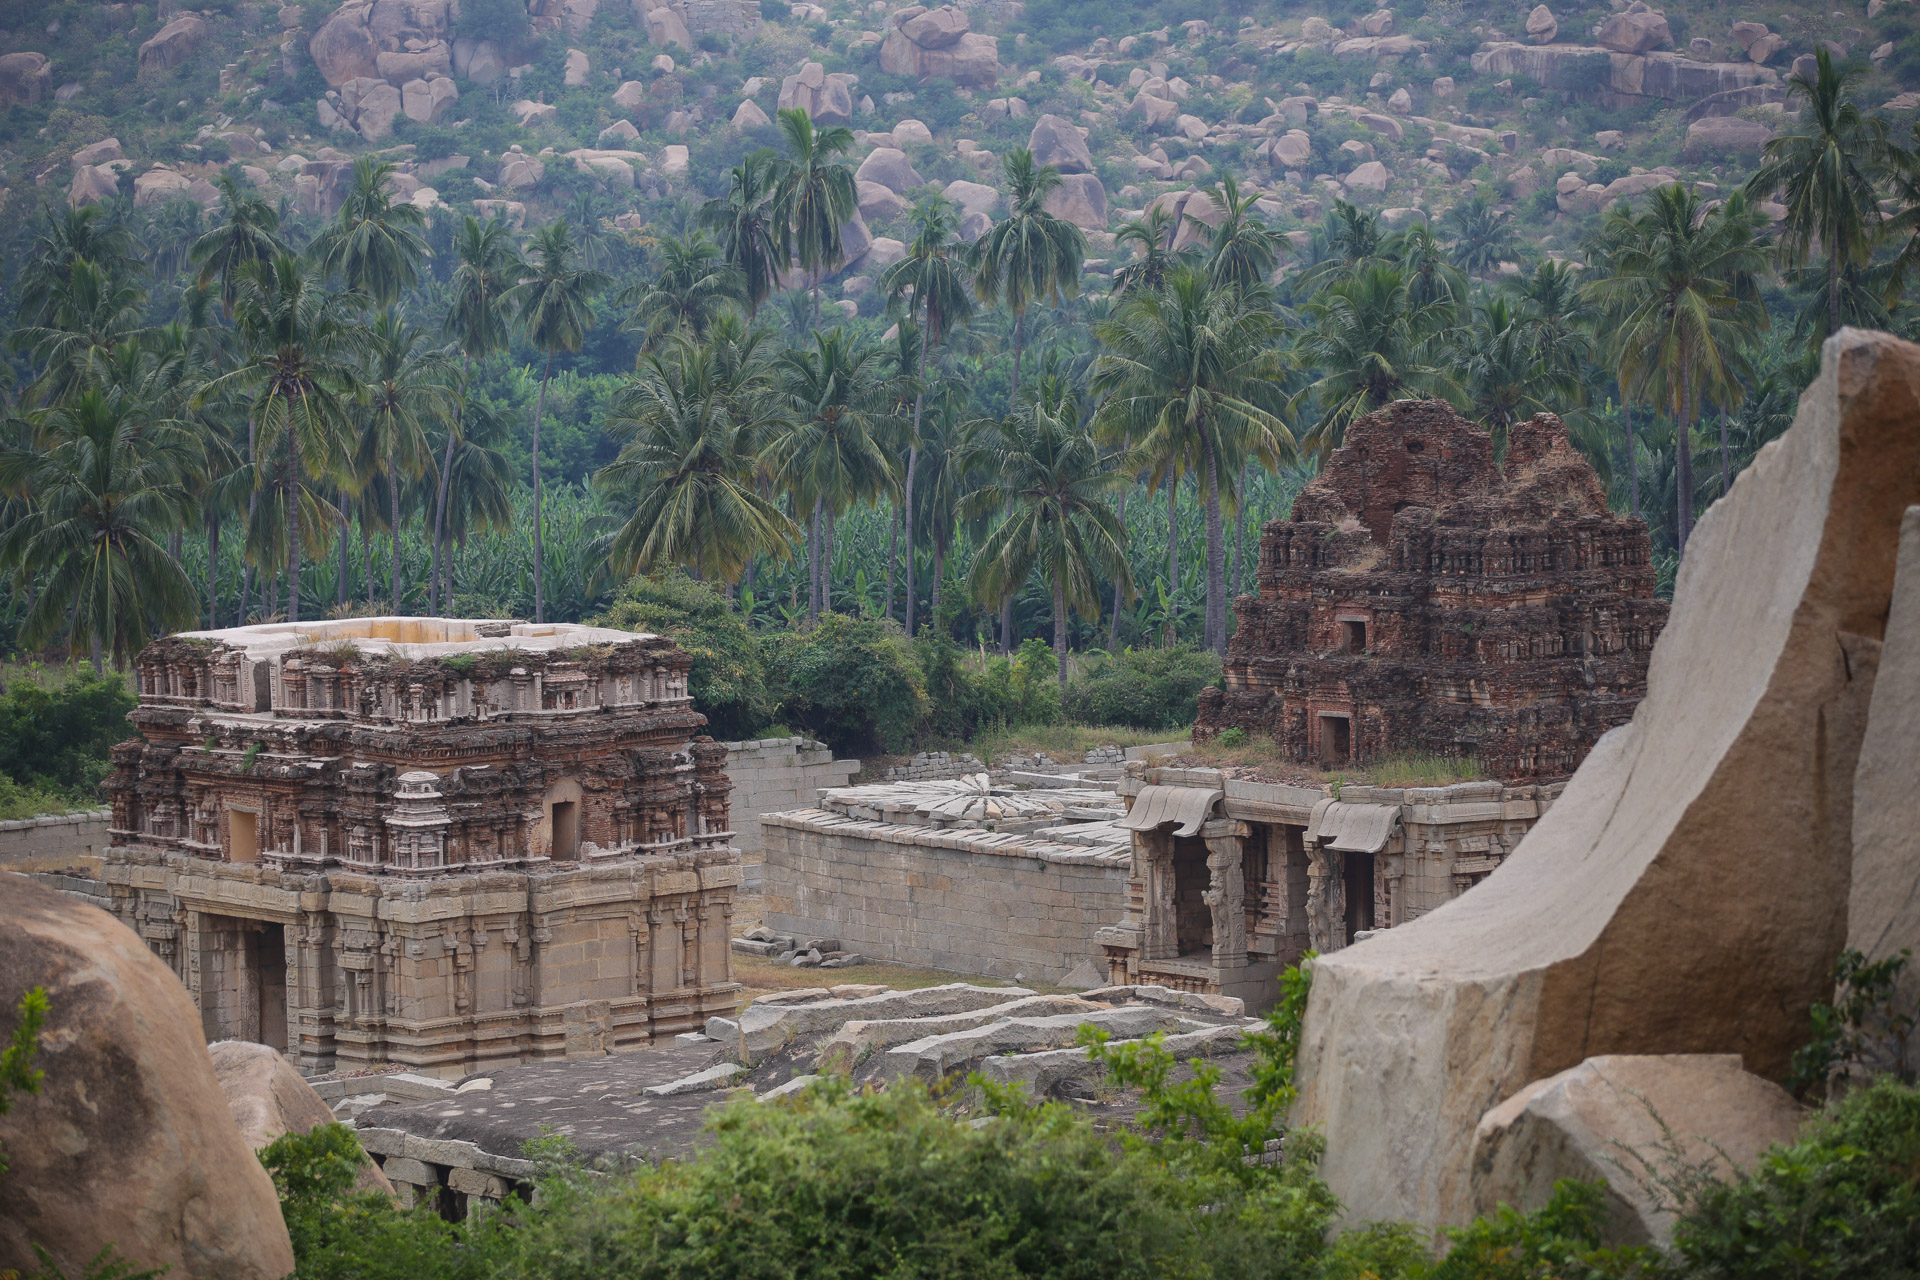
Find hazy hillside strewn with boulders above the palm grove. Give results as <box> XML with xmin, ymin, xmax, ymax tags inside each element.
<box><xmin>0</xmin><ymin>0</ymin><xmax>1920</xmax><ymax>293</ymax></box>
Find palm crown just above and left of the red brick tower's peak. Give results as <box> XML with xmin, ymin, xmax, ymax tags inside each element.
<box><xmin>1290</xmin><ymin>265</ymin><xmax>1461</xmax><ymax>453</ymax></box>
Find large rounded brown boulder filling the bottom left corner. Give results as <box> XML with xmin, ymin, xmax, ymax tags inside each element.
<box><xmin>0</xmin><ymin>875</ymin><xmax>294</xmax><ymax>1280</ymax></box>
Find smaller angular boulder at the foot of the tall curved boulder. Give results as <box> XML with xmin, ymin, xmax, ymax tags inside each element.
<box><xmin>1473</xmin><ymin>1054</ymin><xmax>1803</xmax><ymax>1245</ymax></box>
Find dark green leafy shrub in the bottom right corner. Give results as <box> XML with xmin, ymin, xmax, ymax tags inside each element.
<box><xmin>1674</xmin><ymin>1079</ymin><xmax>1920</xmax><ymax>1280</ymax></box>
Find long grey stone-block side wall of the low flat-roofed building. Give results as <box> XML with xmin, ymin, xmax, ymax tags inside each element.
<box><xmin>760</xmin><ymin>810</ymin><xmax>1127</xmax><ymax>983</ymax></box>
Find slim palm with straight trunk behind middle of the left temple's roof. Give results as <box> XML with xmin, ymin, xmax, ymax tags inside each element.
<box><xmin>355</xmin><ymin>311</ymin><xmax>459</xmax><ymax>614</ymax></box>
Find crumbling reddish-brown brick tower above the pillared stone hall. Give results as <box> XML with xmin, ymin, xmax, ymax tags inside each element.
<box><xmin>1196</xmin><ymin>401</ymin><xmax>1667</xmax><ymax>783</ymax></box>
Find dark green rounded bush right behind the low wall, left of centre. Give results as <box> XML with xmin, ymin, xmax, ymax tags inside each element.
<box><xmin>760</xmin><ymin>614</ymin><xmax>927</xmax><ymax>756</ymax></box>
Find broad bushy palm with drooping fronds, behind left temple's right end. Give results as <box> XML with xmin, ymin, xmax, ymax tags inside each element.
<box><xmin>593</xmin><ymin>320</ymin><xmax>799</xmax><ymax>581</ymax></box>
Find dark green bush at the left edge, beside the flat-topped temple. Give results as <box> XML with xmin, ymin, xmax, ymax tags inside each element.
<box><xmin>0</xmin><ymin>674</ymin><xmax>136</xmax><ymax>802</ymax></box>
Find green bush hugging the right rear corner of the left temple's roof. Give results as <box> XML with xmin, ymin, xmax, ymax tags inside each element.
<box><xmin>599</xmin><ymin>570</ymin><xmax>774</xmax><ymax>743</ymax></box>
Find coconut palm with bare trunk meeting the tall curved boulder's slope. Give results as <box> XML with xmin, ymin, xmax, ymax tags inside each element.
<box><xmin>1588</xmin><ymin>186</ymin><xmax>1766</xmax><ymax>555</ymax></box>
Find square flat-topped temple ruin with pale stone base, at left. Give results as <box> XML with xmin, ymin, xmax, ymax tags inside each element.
<box><xmin>102</xmin><ymin>618</ymin><xmax>741</xmax><ymax>1073</ymax></box>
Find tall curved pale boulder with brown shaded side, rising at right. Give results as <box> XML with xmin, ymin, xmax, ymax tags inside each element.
<box><xmin>1292</xmin><ymin>330</ymin><xmax>1920</xmax><ymax>1224</ymax></box>
